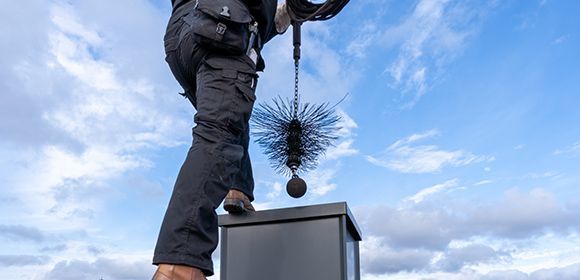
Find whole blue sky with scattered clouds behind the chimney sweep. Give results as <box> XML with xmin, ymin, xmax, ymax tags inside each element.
<box><xmin>0</xmin><ymin>0</ymin><xmax>580</xmax><ymax>280</ymax></box>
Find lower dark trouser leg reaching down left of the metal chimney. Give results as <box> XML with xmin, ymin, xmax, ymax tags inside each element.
<box><xmin>153</xmin><ymin>132</ymin><xmax>227</xmax><ymax>275</ymax></box>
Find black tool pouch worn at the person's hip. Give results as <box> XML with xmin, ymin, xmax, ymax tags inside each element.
<box><xmin>184</xmin><ymin>0</ymin><xmax>253</xmax><ymax>55</ymax></box>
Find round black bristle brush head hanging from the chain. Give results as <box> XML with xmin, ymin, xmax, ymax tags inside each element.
<box><xmin>252</xmin><ymin>98</ymin><xmax>340</xmax><ymax>175</ymax></box>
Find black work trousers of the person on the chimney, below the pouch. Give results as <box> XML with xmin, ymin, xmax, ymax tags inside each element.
<box><xmin>153</xmin><ymin>8</ymin><xmax>257</xmax><ymax>276</ymax></box>
